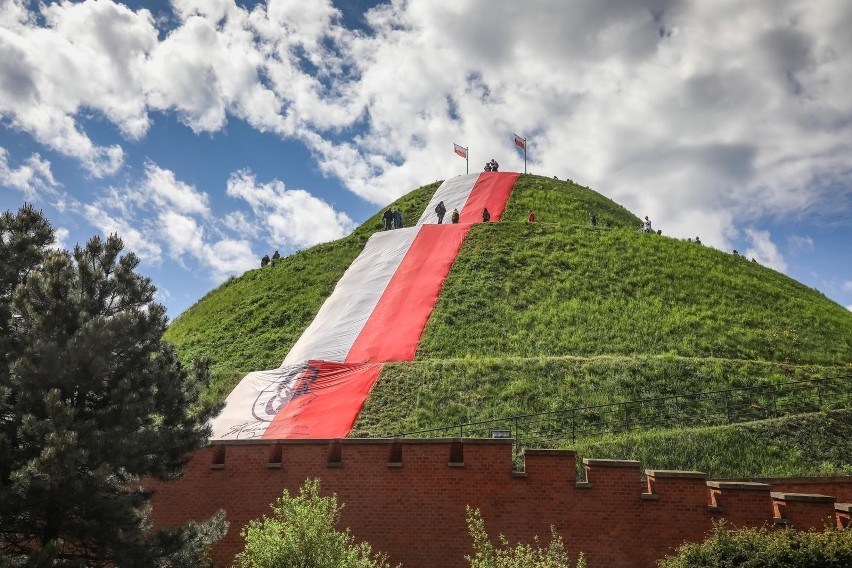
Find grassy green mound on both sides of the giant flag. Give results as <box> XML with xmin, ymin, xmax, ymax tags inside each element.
<box><xmin>166</xmin><ymin>175</ymin><xmax>852</xmax><ymax>476</ymax></box>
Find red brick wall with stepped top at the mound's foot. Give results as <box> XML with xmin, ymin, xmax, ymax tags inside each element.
<box><xmin>148</xmin><ymin>439</ymin><xmax>852</xmax><ymax>568</ymax></box>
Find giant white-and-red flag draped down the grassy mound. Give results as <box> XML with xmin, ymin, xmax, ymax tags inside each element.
<box><xmin>212</xmin><ymin>172</ymin><xmax>518</xmax><ymax>440</ymax></box>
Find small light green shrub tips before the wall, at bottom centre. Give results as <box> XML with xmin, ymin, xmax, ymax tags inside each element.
<box><xmin>465</xmin><ymin>506</ymin><xmax>586</xmax><ymax>568</ymax></box>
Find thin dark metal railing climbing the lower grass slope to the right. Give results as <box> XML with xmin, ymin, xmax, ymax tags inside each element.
<box><xmin>393</xmin><ymin>375</ymin><xmax>852</xmax><ymax>448</ymax></box>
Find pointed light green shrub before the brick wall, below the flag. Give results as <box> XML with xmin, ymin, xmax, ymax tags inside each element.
<box><xmin>235</xmin><ymin>479</ymin><xmax>396</xmax><ymax>568</ymax></box>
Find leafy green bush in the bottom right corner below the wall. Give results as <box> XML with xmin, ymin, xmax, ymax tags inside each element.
<box><xmin>659</xmin><ymin>523</ymin><xmax>852</xmax><ymax>568</ymax></box>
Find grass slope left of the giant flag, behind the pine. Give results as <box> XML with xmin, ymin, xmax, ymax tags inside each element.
<box><xmin>165</xmin><ymin>182</ymin><xmax>440</xmax><ymax>400</ymax></box>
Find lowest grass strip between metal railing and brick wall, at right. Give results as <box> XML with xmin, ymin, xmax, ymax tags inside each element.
<box><xmin>566</xmin><ymin>410</ymin><xmax>852</xmax><ymax>479</ymax></box>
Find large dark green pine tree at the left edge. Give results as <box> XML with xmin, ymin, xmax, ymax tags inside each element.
<box><xmin>0</xmin><ymin>205</ymin><xmax>224</xmax><ymax>567</ymax></box>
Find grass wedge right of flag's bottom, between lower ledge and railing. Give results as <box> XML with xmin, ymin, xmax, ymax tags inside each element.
<box><xmin>351</xmin><ymin>356</ymin><xmax>849</xmax><ymax>437</ymax></box>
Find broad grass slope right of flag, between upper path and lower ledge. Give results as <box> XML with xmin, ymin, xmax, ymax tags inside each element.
<box><xmin>417</xmin><ymin>222</ymin><xmax>852</xmax><ymax>364</ymax></box>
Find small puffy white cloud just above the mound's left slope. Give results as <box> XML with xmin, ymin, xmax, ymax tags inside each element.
<box><xmin>227</xmin><ymin>170</ymin><xmax>355</xmax><ymax>248</ymax></box>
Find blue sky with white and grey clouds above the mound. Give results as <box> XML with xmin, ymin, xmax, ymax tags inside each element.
<box><xmin>0</xmin><ymin>0</ymin><xmax>852</xmax><ymax>317</ymax></box>
